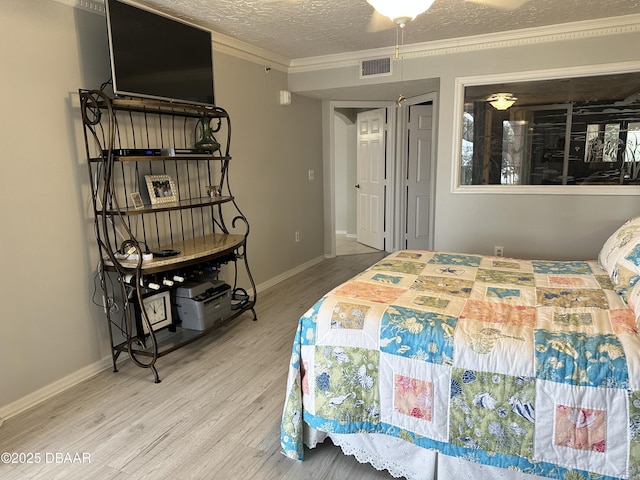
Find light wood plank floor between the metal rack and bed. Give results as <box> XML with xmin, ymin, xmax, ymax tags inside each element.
<box><xmin>0</xmin><ymin>253</ymin><xmax>391</xmax><ymax>480</ymax></box>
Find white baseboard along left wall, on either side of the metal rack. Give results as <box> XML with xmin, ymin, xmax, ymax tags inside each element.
<box><xmin>0</xmin><ymin>255</ymin><xmax>325</xmax><ymax>427</ymax></box>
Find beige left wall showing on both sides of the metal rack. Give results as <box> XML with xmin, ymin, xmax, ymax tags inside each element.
<box><xmin>0</xmin><ymin>0</ymin><xmax>323</xmax><ymax>421</ymax></box>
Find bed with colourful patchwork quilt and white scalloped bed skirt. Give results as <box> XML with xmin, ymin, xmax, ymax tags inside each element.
<box><xmin>281</xmin><ymin>217</ymin><xmax>640</xmax><ymax>480</ymax></box>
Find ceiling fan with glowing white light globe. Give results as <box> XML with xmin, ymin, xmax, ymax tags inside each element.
<box><xmin>367</xmin><ymin>0</ymin><xmax>529</xmax><ymax>32</ymax></box>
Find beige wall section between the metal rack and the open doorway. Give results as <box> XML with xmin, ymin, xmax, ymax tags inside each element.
<box><xmin>214</xmin><ymin>54</ymin><xmax>324</xmax><ymax>283</ymax></box>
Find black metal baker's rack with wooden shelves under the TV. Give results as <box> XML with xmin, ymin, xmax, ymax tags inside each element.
<box><xmin>79</xmin><ymin>90</ymin><xmax>257</xmax><ymax>383</ymax></box>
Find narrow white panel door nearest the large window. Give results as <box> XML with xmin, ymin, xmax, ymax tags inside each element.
<box><xmin>406</xmin><ymin>105</ymin><xmax>433</xmax><ymax>250</ymax></box>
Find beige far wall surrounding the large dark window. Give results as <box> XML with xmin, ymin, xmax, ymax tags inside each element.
<box><xmin>431</xmin><ymin>34</ymin><xmax>640</xmax><ymax>260</ymax></box>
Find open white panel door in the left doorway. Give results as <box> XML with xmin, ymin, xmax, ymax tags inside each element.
<box><xmin>355</xmin><ymin>108</ymin><xmax>385</xmax><ymax>250</ymax></box>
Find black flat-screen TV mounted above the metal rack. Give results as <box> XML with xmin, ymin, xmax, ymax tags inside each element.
<box><xmin>105</xmin><ymin>0</ymin><xmax>215</xmax><ymax>105</ymax></box>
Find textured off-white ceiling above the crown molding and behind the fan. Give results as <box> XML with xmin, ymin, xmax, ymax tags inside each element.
<box><xmin>126</xmin><ymin>0</ymin><xmax>640</xmax><ymax>60</ymax></box>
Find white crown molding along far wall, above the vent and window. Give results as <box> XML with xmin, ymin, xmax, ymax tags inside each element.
<box><xmin>289</xmin><ymin>14</ymin><xmax>640</xmax><ymax>73</ymax></box>
